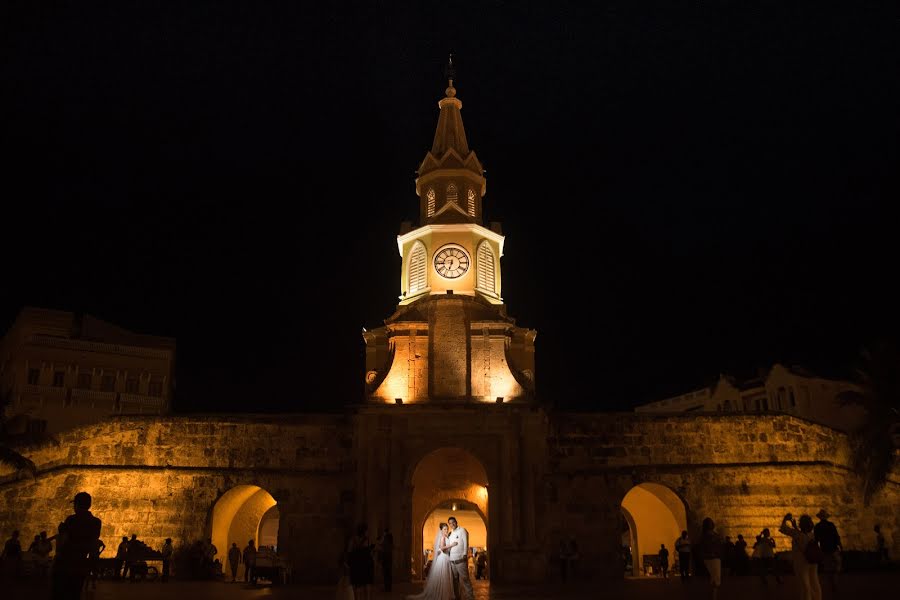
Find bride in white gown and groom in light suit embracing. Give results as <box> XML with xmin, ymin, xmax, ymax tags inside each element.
<box><xmin>407</xmin><ymin>517</ymin><xmax>475</xmax><ymax>600</ymax></box>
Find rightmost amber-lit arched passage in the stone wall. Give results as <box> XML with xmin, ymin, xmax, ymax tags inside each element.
<box><xmin>622</xmin><ymin>483</ymin><xmax>687</xmax><ymax>575</ymax></box>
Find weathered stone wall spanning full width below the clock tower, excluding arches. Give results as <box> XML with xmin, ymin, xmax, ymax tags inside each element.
<box><xmin>0</xmin><ymin>405</ymin><xmax>900</xmax><ymax>582</ymax></box>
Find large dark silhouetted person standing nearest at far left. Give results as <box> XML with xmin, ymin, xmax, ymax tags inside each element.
<box><xmin>52</xmin><ymin>492</ymin><xmax>101</xmax><ymax>600</ymax></box>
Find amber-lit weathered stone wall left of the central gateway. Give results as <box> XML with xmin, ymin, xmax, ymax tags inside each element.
<box><xmin>0</xmin><ymin>416</ymin><xmax>355</xmax><ymax>580</ymax></box>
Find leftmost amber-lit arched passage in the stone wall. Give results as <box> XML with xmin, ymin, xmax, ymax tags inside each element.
<box><xmin>211</xmin><ymin>485</ymin><xmax>278</xmax><ymax>563</ymax></box>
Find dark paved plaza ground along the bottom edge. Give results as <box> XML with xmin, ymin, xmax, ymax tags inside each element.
<box><xmin>0</xmin><ymin>573</ymin><xmax>900</xmax><ymax>600</ymax></box>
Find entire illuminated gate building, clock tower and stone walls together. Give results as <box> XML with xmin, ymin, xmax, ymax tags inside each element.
<box><xmin>0</xmin><ymin>79</ymin><xmax>900</xmax><ymax>583</ymax></box>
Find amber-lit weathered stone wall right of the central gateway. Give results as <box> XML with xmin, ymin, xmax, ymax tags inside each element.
<box><xmin>537</xmin><ymin>414</ymin><xmax>900</xmax><ymax>572</ymax></box>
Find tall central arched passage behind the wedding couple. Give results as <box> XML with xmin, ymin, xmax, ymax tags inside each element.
<box><xmin>411</xmin><ymin>448</ymin><xmax>490</xmax><ymax>579</ymax></box>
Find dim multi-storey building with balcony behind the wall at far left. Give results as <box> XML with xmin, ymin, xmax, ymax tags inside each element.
<box><xmin>0</xmin><ymin>307</ymin><xmax>175</xmax><ymax>433</ymax></box>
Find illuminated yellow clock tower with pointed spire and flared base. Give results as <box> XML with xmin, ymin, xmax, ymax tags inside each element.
<box><xmin>363</xmin><ymin>72</ymin><xmax>536</xmax><ymax>404</ymax></box>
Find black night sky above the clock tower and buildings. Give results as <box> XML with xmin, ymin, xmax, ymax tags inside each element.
<box><xmin>0</xmin><ymin>0</ymin><xmax>900</xmax><ymax>410</ymax></box>
